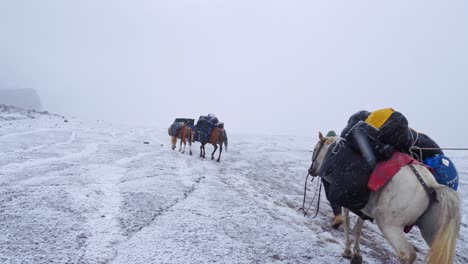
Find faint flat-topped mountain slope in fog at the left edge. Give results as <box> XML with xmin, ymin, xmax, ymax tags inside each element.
<box><xmin>0</xmin><ymin>89</ymin><xmax>42</xmax><ymax>111</ymax></box>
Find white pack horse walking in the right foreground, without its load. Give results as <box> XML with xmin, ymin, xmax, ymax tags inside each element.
<box><xmin>311</xmin><ymin>133</ymin><xmax>461</xmax><ymax>264</ymax></box>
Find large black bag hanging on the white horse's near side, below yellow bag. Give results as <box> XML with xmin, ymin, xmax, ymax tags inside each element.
<box><xmin>320</xmin><ymin>121</ymin><xmax>394</xmax><ymax>218</ymax></box>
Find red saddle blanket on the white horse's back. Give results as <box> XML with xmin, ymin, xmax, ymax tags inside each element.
<box><xmin>367</xmin><ymin>152</ymin><xmax>422</xmax><ymax>192</ymax></box>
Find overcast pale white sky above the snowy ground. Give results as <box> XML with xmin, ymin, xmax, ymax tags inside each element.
<box><xmin>0</xmin><ymin>0</ymin><xmax>468</xmax><ymax>146</ymax></box>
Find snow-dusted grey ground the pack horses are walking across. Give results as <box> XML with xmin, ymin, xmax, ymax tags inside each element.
<box><xmin>0</xmin><ymin>113</ymin><xmax>468</xmax><ymax>263</ymax></box>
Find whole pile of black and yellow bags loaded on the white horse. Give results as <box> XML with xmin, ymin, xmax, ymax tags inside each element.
<box><xmin>326</xmin><ymin>108</ymin><xmax>458</xmax><ymax>217</ymax></box>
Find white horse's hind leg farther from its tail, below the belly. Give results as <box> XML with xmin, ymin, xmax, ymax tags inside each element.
<box><xmin>376</xmin><ymin>223</ymin><xmax>416</xmax><ymax>264</ymax></box>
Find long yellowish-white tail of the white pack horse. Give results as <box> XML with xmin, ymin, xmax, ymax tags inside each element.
<box><xmin>426</xmin><ymin>185</ymin><xmax>461</xmax><ymax>264</ymax></box>
